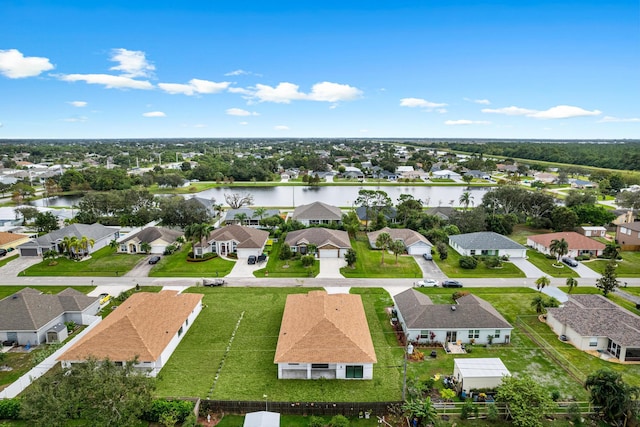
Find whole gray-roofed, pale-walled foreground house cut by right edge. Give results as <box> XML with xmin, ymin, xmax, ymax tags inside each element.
<box><xmin>547</xmin><ymin>294</ymin><xmax>640</xmax><ymax>362</ymax></box>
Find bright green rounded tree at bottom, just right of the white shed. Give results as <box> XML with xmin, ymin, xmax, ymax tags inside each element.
<box><xmin>496</xmin><ymin>375</ymin><xmax>554</xmax><ymax>427</ymax></box>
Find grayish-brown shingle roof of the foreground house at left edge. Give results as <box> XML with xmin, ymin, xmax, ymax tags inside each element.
<box><xmin>0</xmin><ymin>288</ymin><xmax>97</xmax><ymax>331</ymax></box>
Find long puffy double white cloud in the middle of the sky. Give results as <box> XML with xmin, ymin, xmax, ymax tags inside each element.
<box><xmin>251</xmin><ymin>82</ymin><xmax>362</xmax><ymax>104</ymax></box>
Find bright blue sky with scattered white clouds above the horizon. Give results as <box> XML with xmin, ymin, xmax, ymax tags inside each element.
<box><xmin>0</xmin><ymin>0</ymin><xmax>640</xmax><ymax>139</ymax></box>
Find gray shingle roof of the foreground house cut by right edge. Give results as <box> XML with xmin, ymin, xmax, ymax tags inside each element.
<box><xmin>547</xmin><ymin>295</ymin><xmax>640</xmax><ymax>347</ymax></box>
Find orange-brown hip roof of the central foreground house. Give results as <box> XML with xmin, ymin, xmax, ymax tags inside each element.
<box><xmin>274</xmin><ymin>291</ymin><xmax>377</xmax><ymax>363</ymax></box>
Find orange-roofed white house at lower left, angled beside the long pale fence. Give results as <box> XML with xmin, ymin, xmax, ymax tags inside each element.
<box><xmin>58</xmin><ymin>291</ymin><xmax>203</xmax><ymax>377</ymax></box>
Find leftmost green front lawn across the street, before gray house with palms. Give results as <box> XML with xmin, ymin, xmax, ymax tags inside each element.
<box><xmin>20</xmin><ymin>246</ymin><xmax>145</xmax><ymax>277</ymax></box>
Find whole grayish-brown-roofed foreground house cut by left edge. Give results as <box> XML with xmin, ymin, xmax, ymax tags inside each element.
<box><xmin>0</xmin><ymin>288</ymin><xmax>100</xmax><ymax>346</ymax></box>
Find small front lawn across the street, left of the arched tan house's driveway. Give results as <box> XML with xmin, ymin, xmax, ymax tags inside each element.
<box><xmin>149</xmin><ymin>243</ymin><xmax>235</xmax><ymax>277</ymax></box>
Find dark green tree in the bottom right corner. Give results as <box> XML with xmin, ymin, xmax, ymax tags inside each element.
<box><xmin>585</xmin><ymin>368</ymin><xmax>640</xmax><ymax>426</ymax></box>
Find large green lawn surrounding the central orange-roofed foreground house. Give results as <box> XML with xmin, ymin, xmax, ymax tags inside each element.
<box><xmin>157</xmin><ymin>288</ymin><xmax>402</xmax><ymax>401</ymax></box>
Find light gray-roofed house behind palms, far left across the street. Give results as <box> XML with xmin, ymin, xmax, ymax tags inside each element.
<box><xmin>18</xmin><ymin>223</ymin><xmax>119</xmax><ymax>256</ymax></box>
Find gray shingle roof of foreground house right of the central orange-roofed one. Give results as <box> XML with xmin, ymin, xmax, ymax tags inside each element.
<box><xmin>394</xmin><ymin>289</ymin><xmax>513</xmax><ymax>330</ymax></box>
